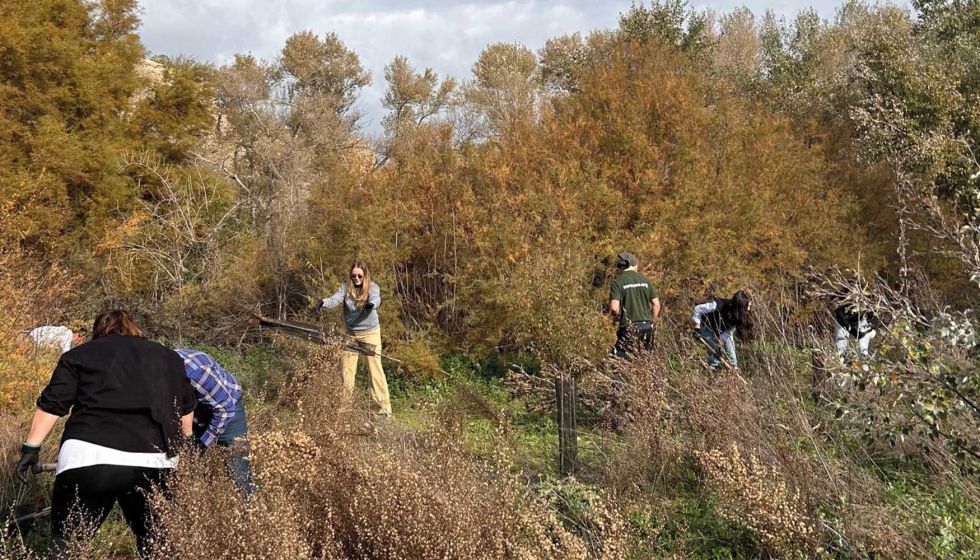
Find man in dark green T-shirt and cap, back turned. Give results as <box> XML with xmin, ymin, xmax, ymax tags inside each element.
<box><xmin>609</xmin><ymin>253</ymin><xmax>660</xmax><ymax>359</ymax></box>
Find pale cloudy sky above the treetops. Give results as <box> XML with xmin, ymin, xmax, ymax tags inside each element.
<box><xmin>141</xmin><ymin>0</ymin><xmax>838</xmax><ymax>131</ymax></box>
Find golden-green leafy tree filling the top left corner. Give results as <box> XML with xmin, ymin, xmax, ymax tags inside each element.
<box><xmin>0</xmin><ymin>0</ymin><xmax>143</xmax><ymax>255</ymax></box>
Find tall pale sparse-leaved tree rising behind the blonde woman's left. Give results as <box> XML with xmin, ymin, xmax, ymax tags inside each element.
<box><xmin>207</xmin><ymin>32</ymin><xmax>373</xmax><ymax>316</ymax></box>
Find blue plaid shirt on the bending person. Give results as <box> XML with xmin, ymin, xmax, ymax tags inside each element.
<box><xmin>177</xmin><ymin>348</ymin><xmax>242</xmax><ymax>447</ymax></box>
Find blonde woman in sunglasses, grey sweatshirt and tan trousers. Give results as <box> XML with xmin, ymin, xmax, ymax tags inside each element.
<box><xmin>316</xmin><ymin>261</ymin><xmax>391</xmax><ymax>417</ymax></box>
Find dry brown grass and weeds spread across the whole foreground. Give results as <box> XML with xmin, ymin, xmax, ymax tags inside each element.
<box><xmin>7</xmin><ymin>308</ymin><xmax>977</xmax><ymax>560</ymax></box>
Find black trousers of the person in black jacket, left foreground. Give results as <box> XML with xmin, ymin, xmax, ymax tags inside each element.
<box><xmin>48</xmin><ymin>465</ymin><xmax>169</xmax><ymax>560</ymax></box>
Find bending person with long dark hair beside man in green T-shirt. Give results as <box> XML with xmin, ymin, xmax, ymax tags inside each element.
<box><xmin>691</xmin><ymin>290</ymin><xmax>753</xmax><ymax>369</ymax></box>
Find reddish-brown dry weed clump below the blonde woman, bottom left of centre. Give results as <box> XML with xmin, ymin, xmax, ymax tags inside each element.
<box><xmin>145</xmin><ymin>347</ymin><xmax>588</xmax><ymax>559</ymax></box>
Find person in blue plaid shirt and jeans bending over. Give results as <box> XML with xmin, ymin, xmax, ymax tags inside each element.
<box><xmin>177</xmin><ymin>348</ymin><xmax>255</xmax><ymax>496</ymax></box>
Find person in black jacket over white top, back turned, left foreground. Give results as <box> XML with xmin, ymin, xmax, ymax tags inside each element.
<box><xmin>16</xmin><ymin>310</ymin><xmax>197</xmax><ymax>558</ymax></box>
